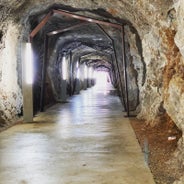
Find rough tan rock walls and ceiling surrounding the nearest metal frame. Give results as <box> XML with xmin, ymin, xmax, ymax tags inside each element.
<box><xmin>0</xmin><ymin>0</ymin><xmax>184</xmax><ymax>183</ymax></box>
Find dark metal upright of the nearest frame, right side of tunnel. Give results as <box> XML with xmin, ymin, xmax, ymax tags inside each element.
<box><xmin>121</xmin><ymin>25</ymin><xmax>130</xmax><ymax>117</ymax></box>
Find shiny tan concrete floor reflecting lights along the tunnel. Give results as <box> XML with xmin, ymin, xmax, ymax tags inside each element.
<box><xmin>0</xmin><ymin>84</ymin><xmax>154</xmax><ymax>184</ymax></box>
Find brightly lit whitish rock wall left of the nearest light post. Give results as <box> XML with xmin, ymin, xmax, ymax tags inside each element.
<box><xmin>0</xmin><ymin>21</ymin><xmax>22</xmax><ymax>124</ymax></box>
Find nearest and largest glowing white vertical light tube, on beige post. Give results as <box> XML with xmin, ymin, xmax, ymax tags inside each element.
<box><xmin>25</xmin><ymin>43</ymin><xmax>33</xmax><ymax>84</ymax></box>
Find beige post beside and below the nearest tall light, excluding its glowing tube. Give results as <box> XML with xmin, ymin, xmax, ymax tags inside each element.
<box><xmin>21</xmin><ymin>43</ymin><xmax>33</xmax><ymax>122</ymax></box>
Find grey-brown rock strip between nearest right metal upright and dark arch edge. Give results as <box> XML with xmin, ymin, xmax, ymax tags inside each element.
<box><xmin>125</xmin><ymin>26</ymin><xmax>145</xmax><ymax>112</ymax></box>
